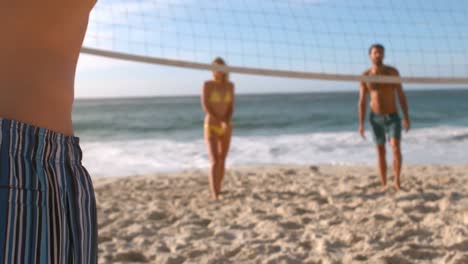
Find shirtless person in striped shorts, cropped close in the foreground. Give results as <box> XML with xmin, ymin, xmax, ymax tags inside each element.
<box><xmin>0</xmin><ymin>0</ymin><xmax>97</xmax><ymax>264</ymax></box>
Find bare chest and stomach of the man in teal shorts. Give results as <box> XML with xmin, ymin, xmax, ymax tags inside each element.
<box><xmin>362</xmin><ymin>66</ymin><xmax>400</xmax><ymax>114</ymax></box>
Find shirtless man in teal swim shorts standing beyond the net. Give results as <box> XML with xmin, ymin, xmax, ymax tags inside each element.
<box><xmin>359</xmin><ymin>44</ymin><xmax>410</xmax><ymax>191</ymax></box>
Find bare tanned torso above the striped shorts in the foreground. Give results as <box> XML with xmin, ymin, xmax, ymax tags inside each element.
<box><xmin>0</xmin><ymin>0</ymin><xmax>95</xmax><ymax>135</ymax></box>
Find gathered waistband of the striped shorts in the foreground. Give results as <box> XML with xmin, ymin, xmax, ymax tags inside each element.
<box><xmin>0</xmin><ymin>118</ymin><xmax>82</xmax><ymax>162</ymax></box>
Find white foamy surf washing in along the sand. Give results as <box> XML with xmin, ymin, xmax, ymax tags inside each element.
<box><xmin>82</xmin><ymin>127</ymin><xmax>468</xmax><ymax>177</ymax></box>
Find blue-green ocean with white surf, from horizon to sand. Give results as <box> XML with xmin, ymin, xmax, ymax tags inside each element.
<box><xmin>73</xmin><ymin>89</ymin><xmax>468</xmax><ymax>177</ymax></box>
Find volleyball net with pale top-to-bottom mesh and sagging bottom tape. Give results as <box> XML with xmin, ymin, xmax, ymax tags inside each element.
<box><xmin>82</xmin><ymin>0</ymin><xmax>468</xmax><ymax>84</ymax></box>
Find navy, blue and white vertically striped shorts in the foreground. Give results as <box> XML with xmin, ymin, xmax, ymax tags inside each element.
<box><xmin>0</xmin><ymin>119</ymin><xmax>97</xmax><ymax>264</ymax></box>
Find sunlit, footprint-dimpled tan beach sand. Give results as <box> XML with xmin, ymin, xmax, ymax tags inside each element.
<box><xmin>94</xmin><ymin>165</ymin><xmax>468</xmax><ymax>264</ymax></box>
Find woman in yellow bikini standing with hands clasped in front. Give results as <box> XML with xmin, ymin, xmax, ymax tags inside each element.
<box><xmin>201</xmin><ymin>58</ymin><xmax>234</xmax><ymax>200</ymax></box>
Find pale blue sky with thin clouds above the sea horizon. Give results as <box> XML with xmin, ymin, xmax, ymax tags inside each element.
<box><xmin>76</xmin><ymin>0</ymin><xmax>468</xmax><ymax>98</ymax></box>
